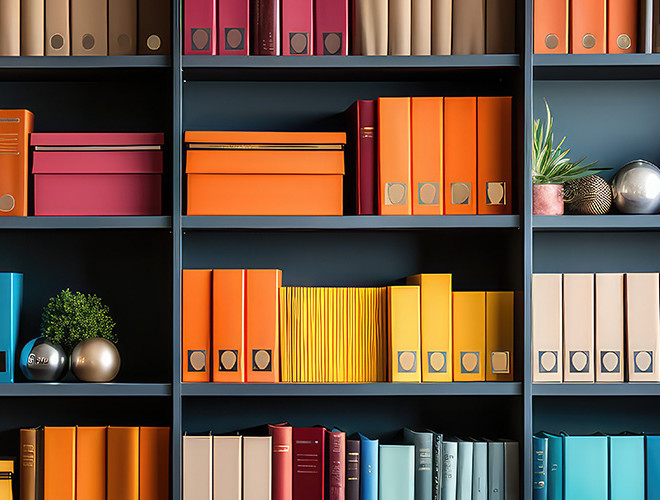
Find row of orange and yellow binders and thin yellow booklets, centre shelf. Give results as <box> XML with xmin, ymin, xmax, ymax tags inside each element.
<box><xmin>182</xmin><ymin>269</ymin><xmax>514</xmax><ymax>382</ymax></box>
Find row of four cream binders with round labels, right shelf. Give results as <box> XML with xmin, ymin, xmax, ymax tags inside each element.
<box><xmin>532</xmin><ymin>273</ymin><xmax>660</xmax><ymax>383</ymax></box>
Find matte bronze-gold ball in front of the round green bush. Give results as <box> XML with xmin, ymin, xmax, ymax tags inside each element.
<box><xmin>71</xmin><ymin>337</ymin><xmax>121</xmax><ymax>382</ymax></box>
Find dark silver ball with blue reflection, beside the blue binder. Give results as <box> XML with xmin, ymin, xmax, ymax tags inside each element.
<box><xmin>19</xmin><ymin>337</ymin><xmax>69</xmax><ymax>382</ymax></box>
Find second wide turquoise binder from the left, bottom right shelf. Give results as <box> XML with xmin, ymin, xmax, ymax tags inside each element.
<box><xmin>608</xmin><ymin>436</ymin><xmax>645</xmax><ymax>500</ymax></box>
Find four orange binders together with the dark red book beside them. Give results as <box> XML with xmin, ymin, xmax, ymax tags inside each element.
<box><xmin>346</xmin><ymin>96</ymin><xmax>513</xmax><ymax>215</ymax></box>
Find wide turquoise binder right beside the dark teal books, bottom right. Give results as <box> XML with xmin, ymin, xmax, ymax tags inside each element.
<box><xmin>564</xmin><ymin>435</ymin><xmax>609</xmax><ymax>500</ymax></box>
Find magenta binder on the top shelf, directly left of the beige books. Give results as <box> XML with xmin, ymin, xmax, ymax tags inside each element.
<box><xmin>314</xmin><ymin>0</ymin><xmax>348</xmax><ymax>56</ymax></box>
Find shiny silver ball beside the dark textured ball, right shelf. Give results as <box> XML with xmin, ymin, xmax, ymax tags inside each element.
<box><xmin>612</xmin><ymin>160</ymin><xmax>660</xmax><ymax>214</ymax></box>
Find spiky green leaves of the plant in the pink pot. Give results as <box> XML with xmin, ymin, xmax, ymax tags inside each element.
<box><xmin>532</xmin><ymin>102</ymin><xmax>601</xmax><ymax>184</ymax></box>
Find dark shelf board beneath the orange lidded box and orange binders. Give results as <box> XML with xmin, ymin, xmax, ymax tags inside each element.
<box><xmin>182</xmin><ymin>215</ymin><xmax>520</xmax><ymax>231</ymax></box>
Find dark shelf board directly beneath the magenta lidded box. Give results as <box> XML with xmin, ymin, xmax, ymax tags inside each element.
<box><xmin>0</xmin><ymin>216</ymin><xmax>172</xmax><ymax>230</ymax></box>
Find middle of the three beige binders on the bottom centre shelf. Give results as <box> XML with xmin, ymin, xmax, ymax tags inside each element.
<box><xmin>213</xmin><ymin>436</ymin><xmax>243</xmax><ymax>500</ymax></box>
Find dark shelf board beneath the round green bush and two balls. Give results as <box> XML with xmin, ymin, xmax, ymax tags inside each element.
<box><xmin>0</xmin><ymin>382</ymin><xmax>172</xmax><ymax>397</ymax></box>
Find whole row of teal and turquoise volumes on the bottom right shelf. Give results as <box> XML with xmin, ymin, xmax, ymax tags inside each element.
<box><xmin>532</xmin><ymin>432</ymin><xmax>660</xmax><ymax>500</ymax></box>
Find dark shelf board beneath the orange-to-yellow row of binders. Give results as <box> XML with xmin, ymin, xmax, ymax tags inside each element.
<box><xmin>181</xmin><ymin>382</ymin><xmax>522</xmax><ymax>396</ymax></box>
